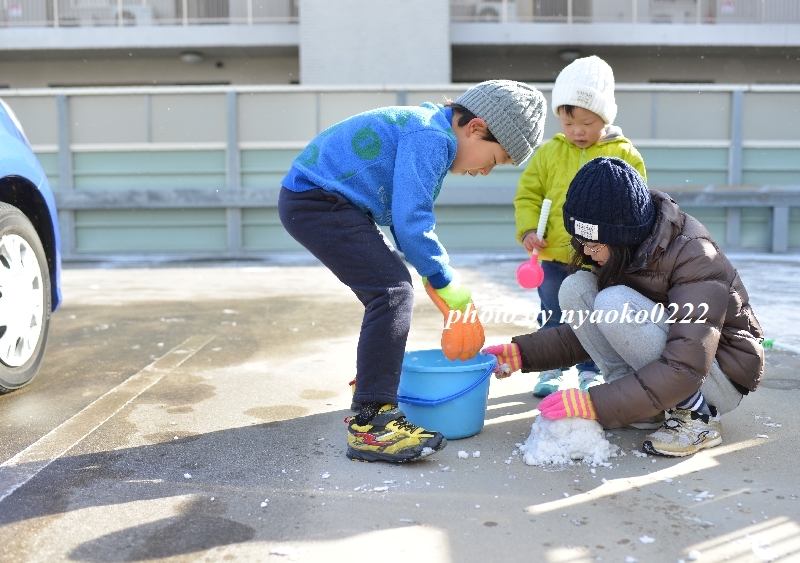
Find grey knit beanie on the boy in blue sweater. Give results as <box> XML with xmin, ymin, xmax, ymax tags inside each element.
<box><xmin>455</xmin><ymin>80</ymin><xmax>547</xmax><ymax>166</ymax></box>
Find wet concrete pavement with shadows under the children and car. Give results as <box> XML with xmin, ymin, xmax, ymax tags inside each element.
<box><xmin>0</xmin><ymin>257</ymin><xmax>800</xmax><ymax>563</ymax></box>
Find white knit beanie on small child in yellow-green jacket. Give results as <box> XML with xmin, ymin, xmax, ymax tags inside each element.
<box><xmin>551</xmin><ymin>55</ymin><xmax>617</xmax><ymax>124</ymax></box>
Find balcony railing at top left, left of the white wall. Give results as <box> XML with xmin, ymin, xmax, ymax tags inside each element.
<box><xmin>0</xmin><ymin>0</ymin><xmax>298</xmax><ymax>27</ymax></box>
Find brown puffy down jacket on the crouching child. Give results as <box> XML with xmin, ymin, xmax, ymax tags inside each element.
<box><xmin>512</xmin><ymin>190</ymin><xmax>764</xmax><ymax>428</ymax></box>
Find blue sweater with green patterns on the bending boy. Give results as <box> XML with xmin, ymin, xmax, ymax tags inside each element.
<box><xmin>282</xmin><ymin>102</ymin><xmax>456</xmax><ymax>289</ymax></box>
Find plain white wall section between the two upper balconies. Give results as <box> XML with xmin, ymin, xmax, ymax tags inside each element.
<box><xmin>300</xmin><ymin>0</ymin><xmax>450</xmax><ymax>85</ymax></box>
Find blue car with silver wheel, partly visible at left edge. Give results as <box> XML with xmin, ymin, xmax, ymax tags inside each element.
<box><xmin>0</xmin><ymin>100</ymin><xmax>61</xmax><ymax>393</ymax></box>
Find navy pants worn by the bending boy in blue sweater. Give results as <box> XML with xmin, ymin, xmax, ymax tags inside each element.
<box><xmin>278</xmin><ymin>188</ymin><xmax>414</xmax><ymax>404</ymax></box>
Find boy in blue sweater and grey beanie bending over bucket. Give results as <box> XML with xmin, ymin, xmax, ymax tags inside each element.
<box><xmin>278</xmin><ymin>80</ymin><xmax>547</xmax><ymax>462</ymax></box>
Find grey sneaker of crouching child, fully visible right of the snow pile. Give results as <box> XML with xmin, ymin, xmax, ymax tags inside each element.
<box><xmin>642</xmin><ymin>407</ymin><xmax>722</xmax><ymax>457</ymax></box>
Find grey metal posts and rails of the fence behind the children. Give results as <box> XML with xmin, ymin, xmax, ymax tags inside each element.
<box><xmin>3</xmin><ymin>84</ymin><xmax>800</xmax><ymax>259</ymax></box>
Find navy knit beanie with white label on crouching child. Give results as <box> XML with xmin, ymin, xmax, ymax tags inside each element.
<box><xmin>562</xmin><ymin>156</ymin><xmax>656</xmax><ymax>246</ymax></box>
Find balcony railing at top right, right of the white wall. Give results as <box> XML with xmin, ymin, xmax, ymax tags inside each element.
<box><xmin>450</xmin><ymin>0</ymin><xmax>800</xmax><ymax>24</ymax></box>
